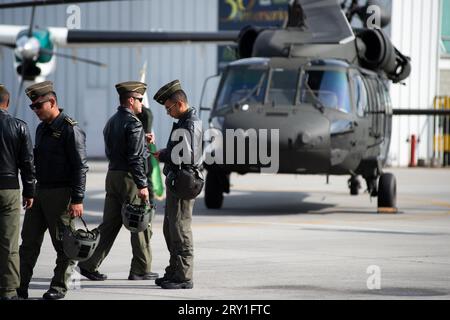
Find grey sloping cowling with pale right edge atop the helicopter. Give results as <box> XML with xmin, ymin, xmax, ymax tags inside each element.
<box><xmin>300</xmin><ymin>0</ymin><xmax>355</xmax><ymax>44</ymax></box>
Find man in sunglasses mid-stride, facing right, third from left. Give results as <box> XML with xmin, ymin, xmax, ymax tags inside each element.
<box><xmin>78</xmin><ymin>81</ymin><xmax>158</xmax><ymax>281</ymax></box>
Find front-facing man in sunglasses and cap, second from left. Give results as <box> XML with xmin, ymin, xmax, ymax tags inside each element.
<box><xmin>17</xmin><ymin>81</ymin><xmax>88</xmax><ymax>300</ymax></box>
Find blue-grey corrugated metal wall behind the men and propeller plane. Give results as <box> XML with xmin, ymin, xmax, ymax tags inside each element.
<box><xmin>0</xmin><ymin>0</ymin><xmax>217</xmax><ymax>157</ymax></box>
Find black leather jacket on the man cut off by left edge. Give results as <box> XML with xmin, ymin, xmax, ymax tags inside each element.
<box><xmin>0</xmin><ymin>109</ymin><xmax>35</xmax><ymax>198</ymax></box>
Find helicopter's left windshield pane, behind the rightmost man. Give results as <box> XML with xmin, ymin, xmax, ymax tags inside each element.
<box><xmin>216</xmin><ymin>66</ymin><xmax>268</xmax><ymax>109</ymax></box>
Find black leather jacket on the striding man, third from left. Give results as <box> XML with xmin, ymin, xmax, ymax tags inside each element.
<box><xmin>103</xmin><ymin>107</ymin><xmax>149</xmax><ymax>189</ymax></box>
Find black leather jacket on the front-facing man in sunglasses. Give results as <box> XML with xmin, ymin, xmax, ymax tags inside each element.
<box><xmin>34</xmin><ymin>112</ymin><xmax>88</xmax><ymax>203</ymax></box>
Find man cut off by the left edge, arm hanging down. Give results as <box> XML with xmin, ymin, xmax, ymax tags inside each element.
<box><xmin>0</xmin><ymin>84</ymin><xmax>35</xmax><ymax>300</ymax></box>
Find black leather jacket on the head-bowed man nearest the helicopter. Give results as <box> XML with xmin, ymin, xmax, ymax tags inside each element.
<box><xmin>159</xmin><ymin>107</ymin><xmax>203</xmax><ymax>176</ymax></box>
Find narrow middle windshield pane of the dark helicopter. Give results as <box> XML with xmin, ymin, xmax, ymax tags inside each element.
<box><xmin>269</xmin><ymin>69</ymin><xmax>298</xmax><ymax>105</ymax></box>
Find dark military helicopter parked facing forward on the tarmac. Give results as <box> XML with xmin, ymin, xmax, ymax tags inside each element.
<box><xmin>202</xmin><ymin>0</ymin><xmax>450</xmax><ymax>212</ymax></box>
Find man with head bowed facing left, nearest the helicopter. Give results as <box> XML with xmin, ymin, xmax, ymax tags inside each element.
<box><xmin>154</xmin><ymin>80</ymin><xmax>202</xmax><ymax>289</ymax></box>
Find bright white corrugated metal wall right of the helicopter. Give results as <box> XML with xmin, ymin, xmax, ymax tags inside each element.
<box><xmin>390</xmin><ymin>0</ymin><xmax>440</xmax><ymax>166</ymax></box>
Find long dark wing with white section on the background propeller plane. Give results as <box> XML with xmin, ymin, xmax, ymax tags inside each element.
<box><xmin>0</xmin><ymin>25</ymin><xmax>239</xmax><ymax>47</ymax></box>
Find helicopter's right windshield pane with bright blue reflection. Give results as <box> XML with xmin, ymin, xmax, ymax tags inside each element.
<box><xmin>300</xmin><ymin>70</ymin><xmax>351</xmax><ymax>112</ymax></box>
